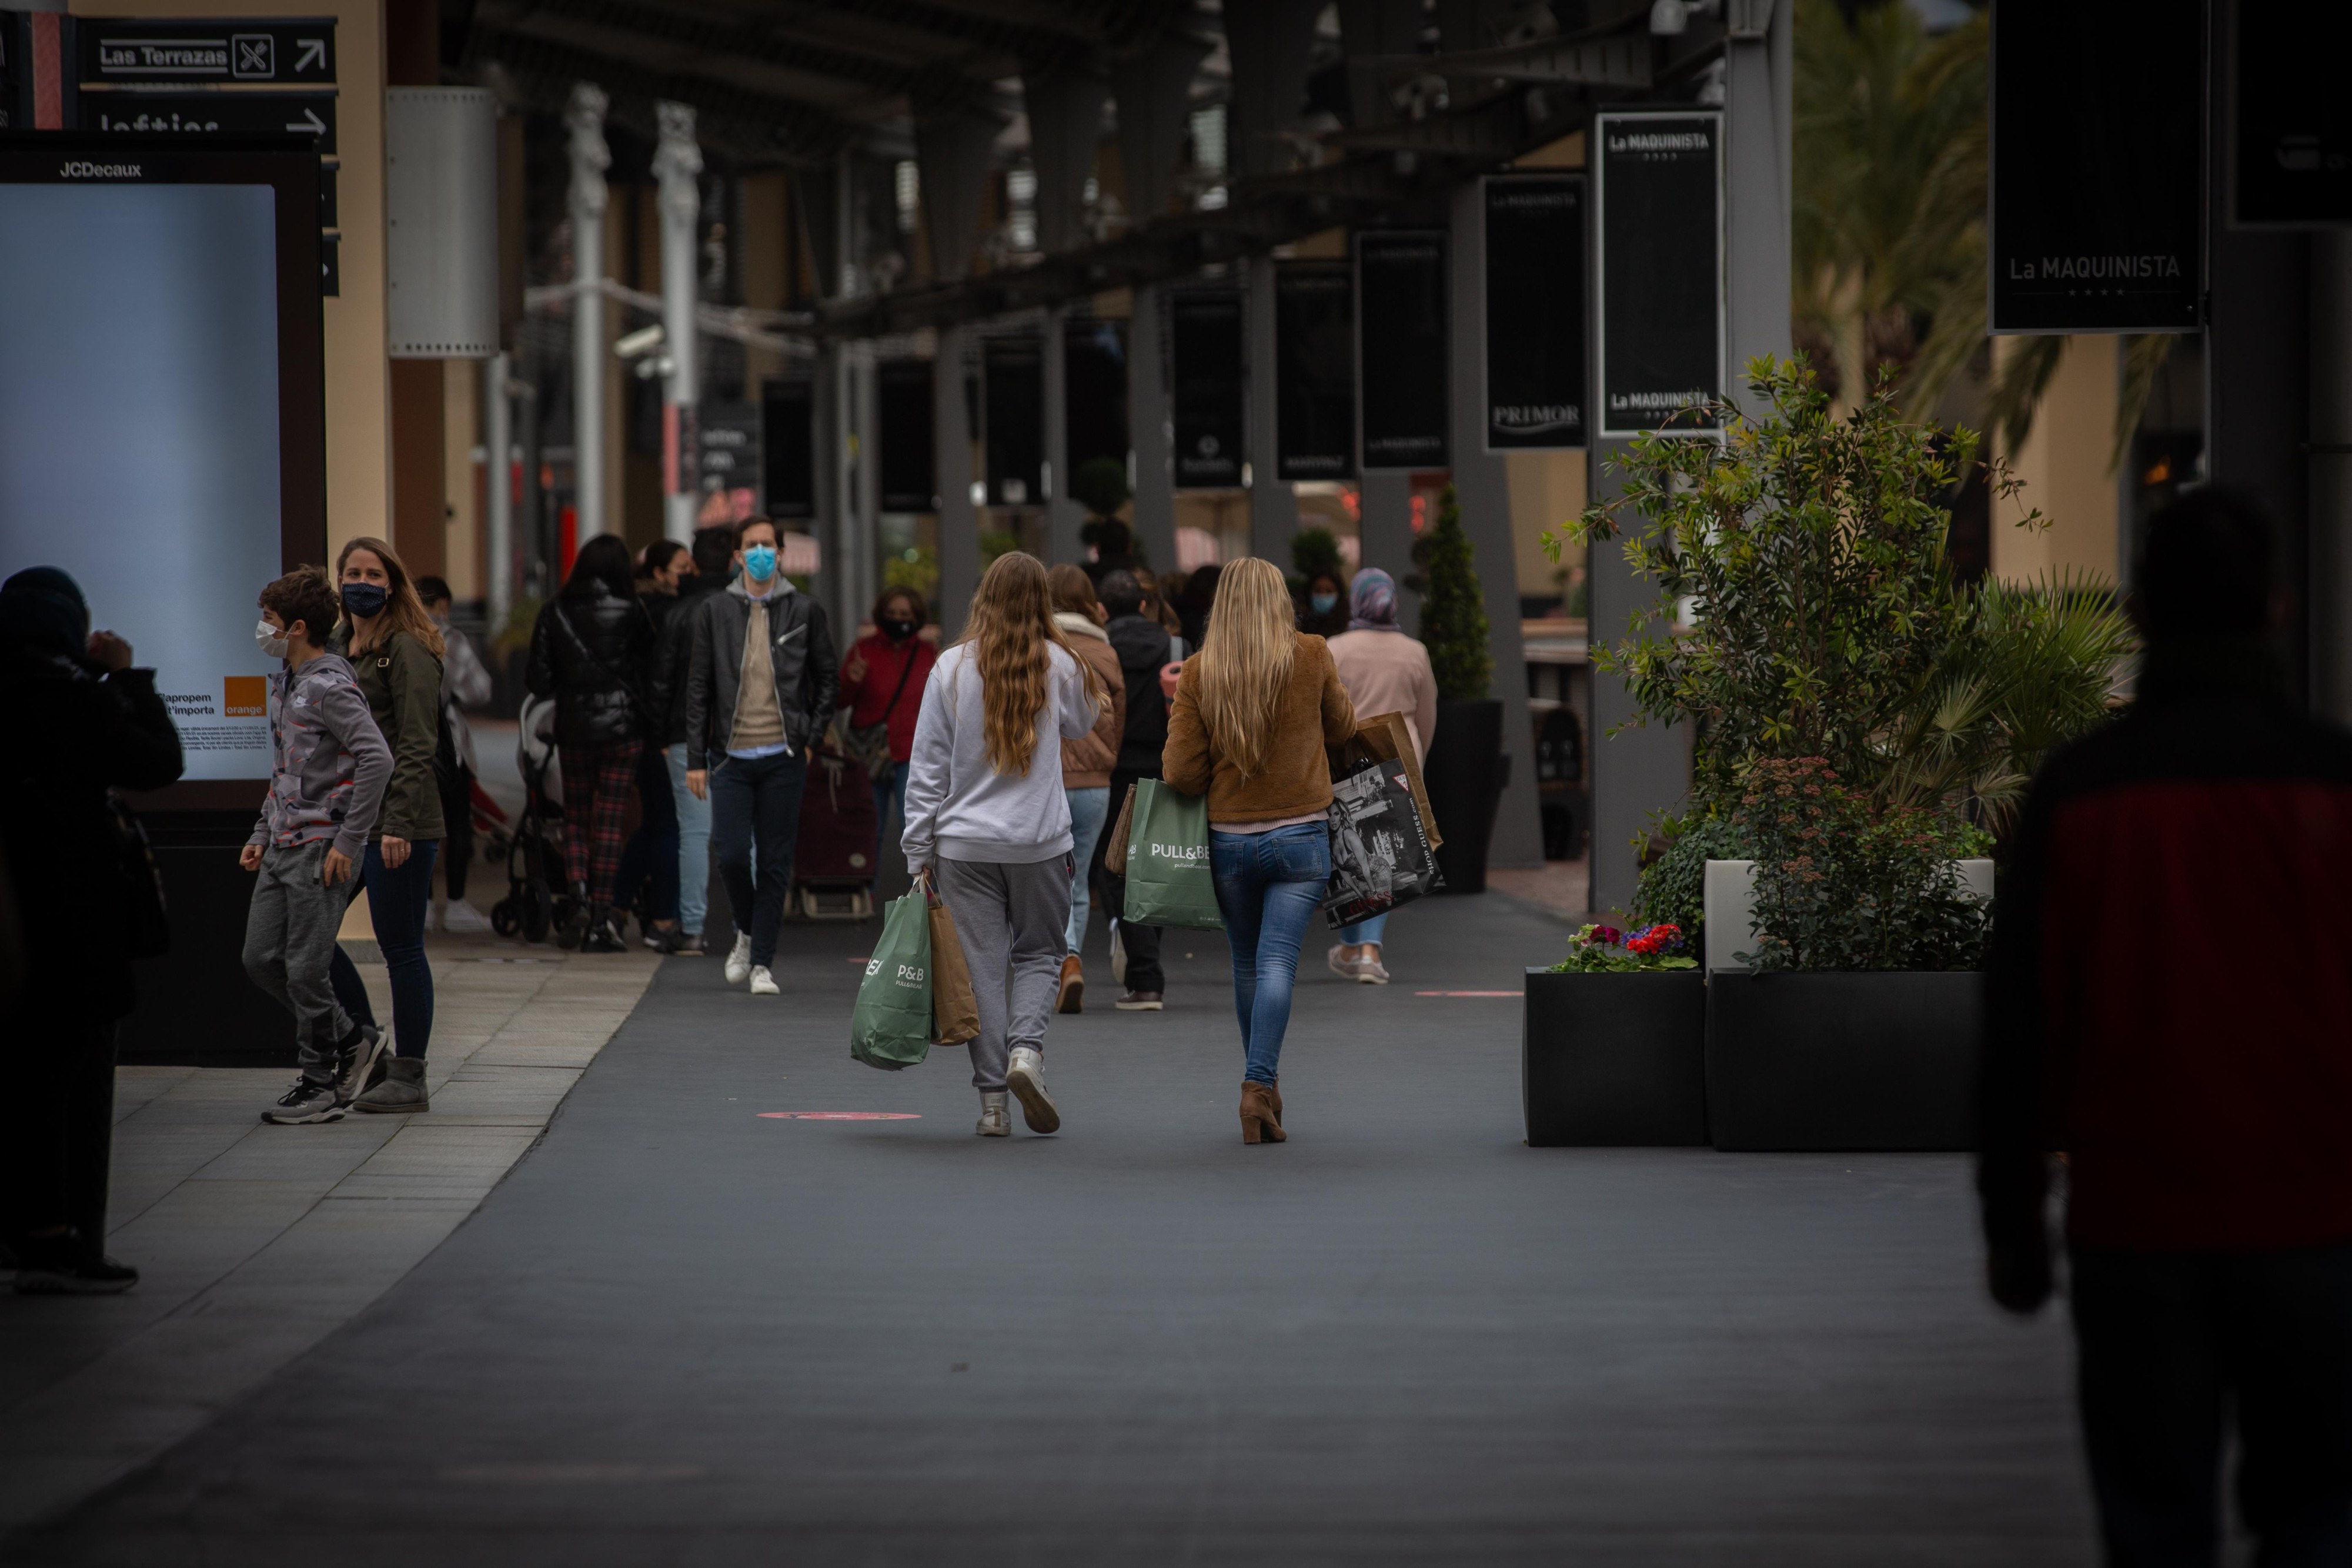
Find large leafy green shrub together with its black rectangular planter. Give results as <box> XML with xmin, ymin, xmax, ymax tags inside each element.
<box><xmin>1545</xmin><ymin>360</ymin><xmax>2129</xmax><ymax>1149</ymax></box>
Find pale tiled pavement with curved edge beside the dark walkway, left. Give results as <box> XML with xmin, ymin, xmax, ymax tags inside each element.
<box><xmin>0</xmin><ymin>938</ymin><xmax>659</xmax><ymax>1533</ymax></box>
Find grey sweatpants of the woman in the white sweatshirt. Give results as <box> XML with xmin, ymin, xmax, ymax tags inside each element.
<box><xmin>938</xmin><ymin>853</ymin><xmax>1073</xmax><ymax>1093</ymax></box>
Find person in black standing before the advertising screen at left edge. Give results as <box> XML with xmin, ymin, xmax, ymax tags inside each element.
<box><xmin>0</xmin><ymin>567</ymin><xmax>181</xmax><ymax>1293</ymax></box>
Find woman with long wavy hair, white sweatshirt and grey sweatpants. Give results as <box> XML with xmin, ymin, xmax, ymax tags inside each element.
<box><xmin>898</xmin><ymin>553</ymin><xmax>1110</xmax><ymax>1138</ymax></box>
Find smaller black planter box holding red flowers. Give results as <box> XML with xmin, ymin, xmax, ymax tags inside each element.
<box><xmin>1519</xmin><ymin>968</ymin><xmax>1708</xmax><ymax>1147</ymax></box>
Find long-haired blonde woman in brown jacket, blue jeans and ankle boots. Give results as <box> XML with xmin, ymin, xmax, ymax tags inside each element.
<box><xmin>1160</xmin><ymin>560</ymin><xmax>1355</xmax><ymax>1142</ymax></box>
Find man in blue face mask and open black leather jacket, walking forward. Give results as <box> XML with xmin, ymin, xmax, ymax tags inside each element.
<box><xmin>687</xmin><ymin>517</ymin><xmax>840</xmax><ymax>997</ymax></box>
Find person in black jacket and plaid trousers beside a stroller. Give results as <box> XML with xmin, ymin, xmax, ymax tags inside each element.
<box><xmin>527</xmin><ymin>534</ymin><xmax>654</xmax><ymax>952</ymax></box>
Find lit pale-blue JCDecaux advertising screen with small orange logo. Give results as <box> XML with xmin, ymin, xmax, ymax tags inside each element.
<box><xmin>0</xmin><ymin>132</ymin><xmax>327</xmax><ymax>799</ymax></box>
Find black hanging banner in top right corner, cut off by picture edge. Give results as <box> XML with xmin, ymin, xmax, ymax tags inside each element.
<box><xmin>2230</xmin><ymin>5</ymin><xmax>2352</xmax><ymax>228</ymax></box>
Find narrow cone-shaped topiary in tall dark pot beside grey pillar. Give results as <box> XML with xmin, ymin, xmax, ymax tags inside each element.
<box><xmin>1404</xmin><ymin>484</ymin><xmax>1508</xmax><ymax>893</ymax></box>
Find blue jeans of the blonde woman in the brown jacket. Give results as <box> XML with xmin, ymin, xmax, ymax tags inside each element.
<box><xmin>1209</xmin><ymin>823</ymin><xmax>1331</xmax><ymax>1084</ymax></box>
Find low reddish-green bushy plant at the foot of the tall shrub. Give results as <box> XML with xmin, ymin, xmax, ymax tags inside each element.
<box><xmin>1731</xmin><ymin>757</ymin><xmax>1992</xmax><ymax>968</ymax></box>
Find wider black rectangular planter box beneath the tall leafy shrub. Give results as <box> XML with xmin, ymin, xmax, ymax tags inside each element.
<box><xmin>1703</xmin><ymin>971</ymin><xmax>1983</xmax><ymax>1149</ymax></box>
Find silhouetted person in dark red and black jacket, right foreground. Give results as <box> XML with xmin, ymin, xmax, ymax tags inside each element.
<box><xmin>1978</xmin><ymin>492</ymin><xmax>2352</xmax><ymax>1568</ymax></box>
